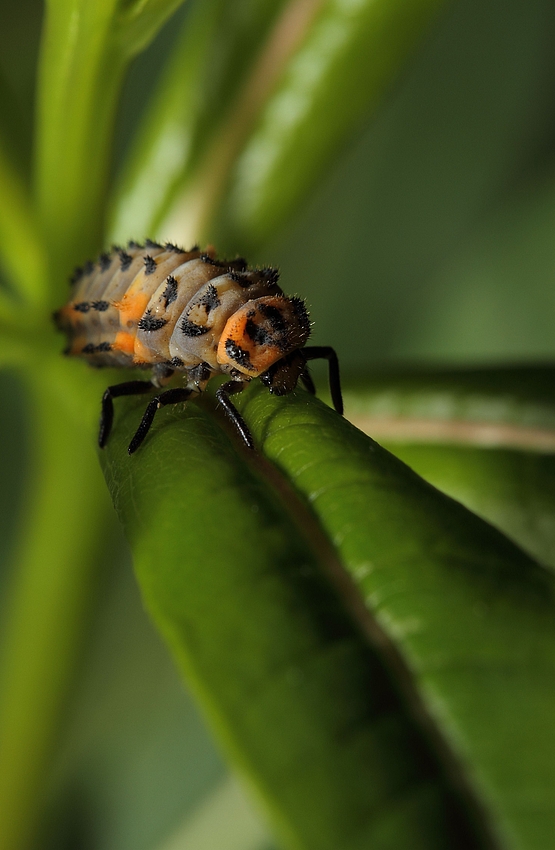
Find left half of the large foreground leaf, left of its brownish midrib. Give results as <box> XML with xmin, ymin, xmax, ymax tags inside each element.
<box><xmin>102</xmin><ymin>390</ymin><xmax>484</xmax><ymax>850</ymax></box>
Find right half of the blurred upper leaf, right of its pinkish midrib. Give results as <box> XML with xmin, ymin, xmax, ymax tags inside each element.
<box><xmin>212</xmin><ymin>0</ymin><xmax>443</xmax><ymax>247</ymax></box>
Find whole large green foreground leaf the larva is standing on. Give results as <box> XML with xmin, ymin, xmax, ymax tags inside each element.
<box><xmin>103</xmin><ymin>386</ymin><xmax>555</xmax><ymax>850</ymax></box>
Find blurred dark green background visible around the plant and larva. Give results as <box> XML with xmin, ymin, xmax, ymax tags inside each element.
<box><xmin>0</xmin><ymin>0</ymin><xmax>555</xmax><ymax>850</ymax></box>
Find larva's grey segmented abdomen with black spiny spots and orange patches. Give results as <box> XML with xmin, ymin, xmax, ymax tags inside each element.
<box><xmin>56</xmin><ymin>242</ymin><xmax>281</xmax><ymax>370</ymax></box>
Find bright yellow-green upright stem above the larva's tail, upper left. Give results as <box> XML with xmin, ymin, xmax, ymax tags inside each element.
<box><xmin>36</xmin><ymin>0</ymin><xmax>190</xmax><ymax>297</ymax></box>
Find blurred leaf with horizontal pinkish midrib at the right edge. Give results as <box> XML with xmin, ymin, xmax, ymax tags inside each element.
<box><xmin>345</xmin><ymin>365</ymin><xmax>555</xmax><ymax>565</ymax></box>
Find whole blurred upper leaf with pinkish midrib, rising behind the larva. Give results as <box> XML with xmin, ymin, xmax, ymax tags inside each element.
<box><xmin>111</xmin><ymin>0</ymin><xmax>448</xmax><ymax>251</ymax></box>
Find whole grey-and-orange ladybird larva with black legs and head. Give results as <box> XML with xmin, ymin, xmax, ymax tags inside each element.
<box><xmin>54</xmin><ymin>240</ymin><xmax>343</xmax><ymax>454</ymax></box>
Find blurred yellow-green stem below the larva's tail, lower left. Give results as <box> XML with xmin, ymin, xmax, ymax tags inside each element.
<box><xmin>0</xmin><ymin>358</ymin><xmax>113</xmax><ymax>850</ymax></box>
